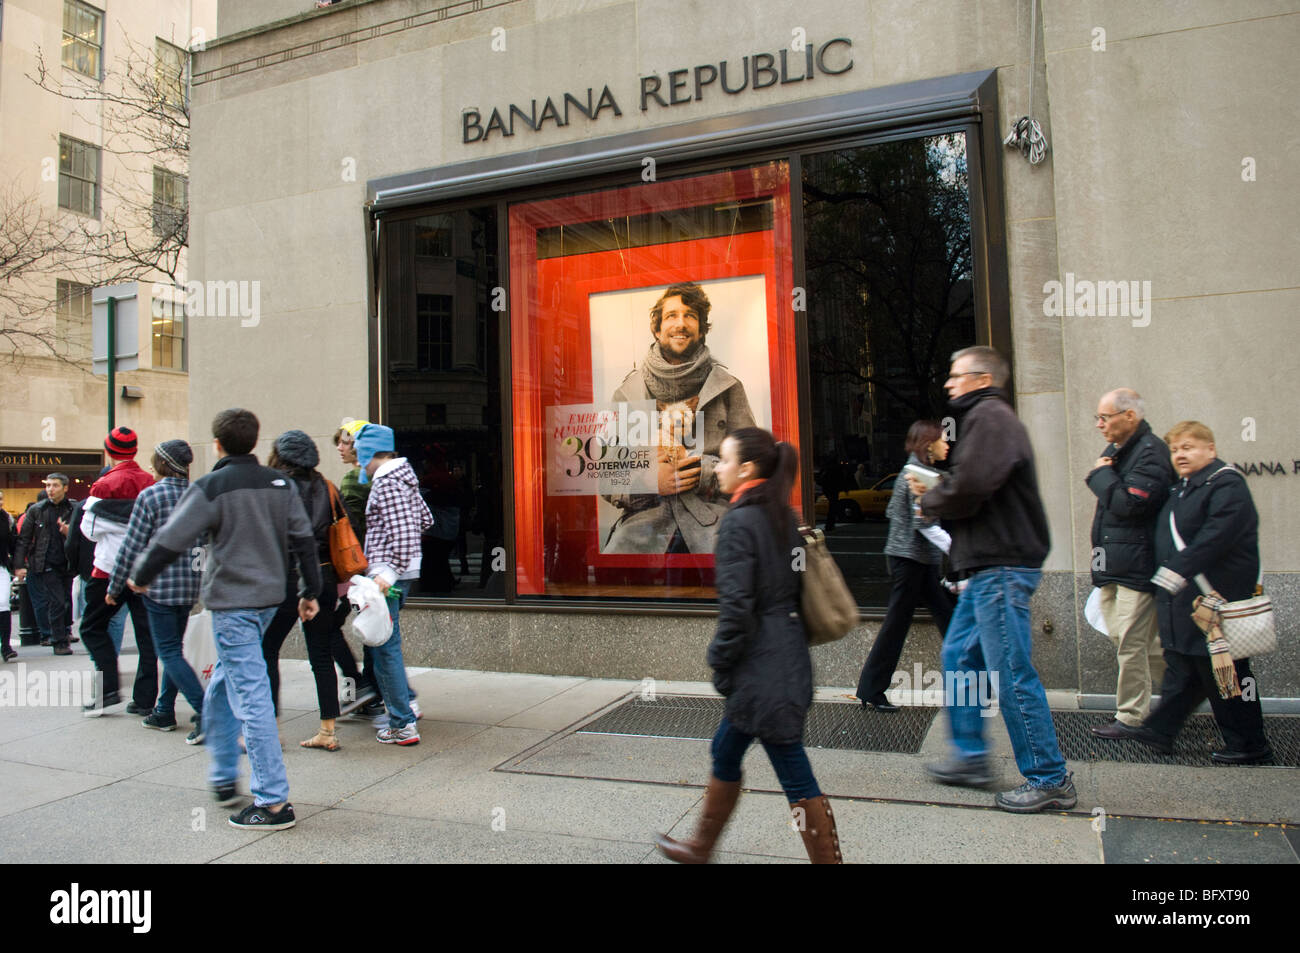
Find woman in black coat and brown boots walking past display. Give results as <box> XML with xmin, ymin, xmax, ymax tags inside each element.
<box><xmin>658</xmin><ymin>428</ymin><xmax>842</xmax><ymax>863</ymax></box>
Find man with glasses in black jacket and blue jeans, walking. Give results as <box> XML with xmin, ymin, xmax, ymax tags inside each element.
<box><xmin>907</xmin><ymin>347</ymin><xmax>1079</xmax><ymax>814</ymax></box>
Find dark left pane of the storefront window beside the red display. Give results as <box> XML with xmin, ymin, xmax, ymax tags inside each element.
<box><xmin>381</xmin><ymin>205</ymin><xmax>506</xmax><ymax>599</ymax></box>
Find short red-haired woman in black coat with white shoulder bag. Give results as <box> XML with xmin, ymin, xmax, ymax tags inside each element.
<box><xmin>1134</xmin><ymin>420</ymin><xmax>1273</xmax><ymax>764</ymax></box>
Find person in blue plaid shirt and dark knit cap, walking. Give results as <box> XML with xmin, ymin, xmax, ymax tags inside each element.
<box><xmin>104</xmin><ymin>439</ymin><xmax>203</xmax><ymax>745</ymax></box>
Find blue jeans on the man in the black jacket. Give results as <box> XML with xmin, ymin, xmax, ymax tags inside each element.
<box><xmin>941</xmin><ymin>566</ymin><xmax>1066</xmax><ymax>788</ymax></box>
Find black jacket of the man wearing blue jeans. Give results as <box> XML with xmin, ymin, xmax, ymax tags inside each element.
<box><xmin>920</xmin><ymin>387</ymin><xmax>1052</xmax><ymax>576</ymax></box>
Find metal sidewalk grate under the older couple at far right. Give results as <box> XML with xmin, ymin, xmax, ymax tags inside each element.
<box><xmin>1052</xmin><ymin>711</ymin><xmax>1300</xmax><ymax>767</ymax></box>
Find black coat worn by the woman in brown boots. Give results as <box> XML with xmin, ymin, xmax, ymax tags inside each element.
<box><xmin>709</xmin><ymin>497</ymin><xmax>813</xmax><ymax>745</ymax></box>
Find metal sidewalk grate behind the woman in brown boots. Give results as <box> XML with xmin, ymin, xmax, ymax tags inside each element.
<box><xmin>579</xmin><ymin>696</ymin><xmax>939</xmax><ymax>754</ymax></box>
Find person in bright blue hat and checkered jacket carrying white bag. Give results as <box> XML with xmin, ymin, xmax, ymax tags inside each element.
<box><xmin>356</xmin><ymin>424</ymin><xmax>433</xmax><ymax>745</ymax></box>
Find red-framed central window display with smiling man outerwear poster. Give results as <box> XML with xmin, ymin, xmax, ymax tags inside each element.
<box><xmin>510</xmin><ymin>161</ymin><xmax>800</xmax><ymax>599</ymax></box>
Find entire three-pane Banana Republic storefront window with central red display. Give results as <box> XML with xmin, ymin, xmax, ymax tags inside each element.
<box><xmin>377</xmin><ymin>102</ymin><xmax>993</xmax><ymax>611</ymax></box>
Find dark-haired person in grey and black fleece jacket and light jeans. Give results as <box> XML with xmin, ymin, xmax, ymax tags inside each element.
<box><xmin>126</xmin><ymin>408</ymin><xmax>321</xmax><ymax>831</ymax></box>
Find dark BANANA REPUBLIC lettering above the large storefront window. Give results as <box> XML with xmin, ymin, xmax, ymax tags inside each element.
<box><xmin>460</xmin><ymin>36</ymin><xmax>853</xmax><ymax>144</ymax></box>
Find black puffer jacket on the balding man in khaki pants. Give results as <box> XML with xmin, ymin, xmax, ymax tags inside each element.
<box><xmin>1086</xmin><ymin>420</ymin><xmax>1177</xmax><ymax>593</ymax></box>
